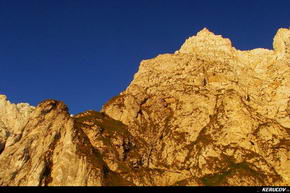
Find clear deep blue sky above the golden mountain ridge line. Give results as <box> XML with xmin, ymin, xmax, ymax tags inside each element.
<box><xmin>0</xmin><ymin>0</ymin><xmax>290</xmax><ymax>114</ymax></box>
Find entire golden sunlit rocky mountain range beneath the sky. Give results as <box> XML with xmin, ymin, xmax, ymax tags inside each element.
<box><xmin>0</xmin><ymin>28</ymin><xmax>290</xmax><ymax>186</ymax></box>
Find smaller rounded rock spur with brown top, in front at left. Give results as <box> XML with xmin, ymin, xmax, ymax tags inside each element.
<box><xmin>0</xmin><ymin>100</ymin><xmax>131</xmax><ymax>186</ymax></box>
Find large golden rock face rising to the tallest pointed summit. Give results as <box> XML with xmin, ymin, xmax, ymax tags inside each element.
<box><xmin>103</xmin><ymin>29</ymin><xmax>290</xmax><ymax>185</ymax></box>
